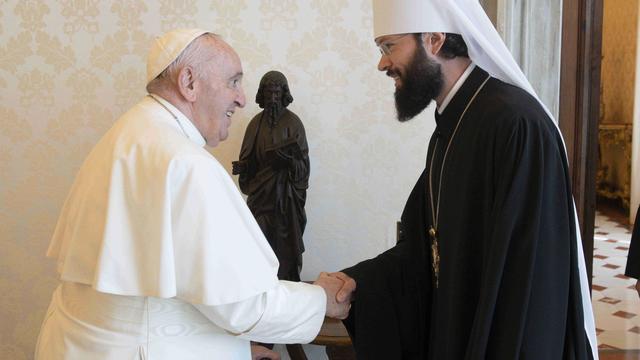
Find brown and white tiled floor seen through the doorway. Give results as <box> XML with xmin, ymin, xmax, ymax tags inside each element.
<box><xmin>592</xmin><ymin>212</ymin><xmax>640</xmax><ymax>349</ymax></box>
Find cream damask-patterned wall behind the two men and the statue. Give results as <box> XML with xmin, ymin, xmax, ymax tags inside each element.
<box><xmin>0</xmin><ymin>0</ymin><xmax>434</xmax><ymax>360</ymax></box>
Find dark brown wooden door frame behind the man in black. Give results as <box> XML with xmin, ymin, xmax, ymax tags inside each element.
<box><xmin>559</xmin><ymin>0</ymin><xmax>603</xmax><ymax>286</ymax></box>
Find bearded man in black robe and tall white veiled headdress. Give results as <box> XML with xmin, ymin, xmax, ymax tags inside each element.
<box><xmin>333</xmin><ymin>0</ymin><xmax>598</xmax><ymax>360</ymax></box>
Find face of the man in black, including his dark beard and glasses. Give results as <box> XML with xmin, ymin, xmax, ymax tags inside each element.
<box><xmin>376</xmin><ymin>34</ymin><xmax>444</xmax><ymax>121</ymax></box>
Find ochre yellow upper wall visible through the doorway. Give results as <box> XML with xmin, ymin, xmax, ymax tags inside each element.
<box><xmin>601</xmin><ymin>0</ymin><xmax>638</xmax><ymax>124</ymax></box>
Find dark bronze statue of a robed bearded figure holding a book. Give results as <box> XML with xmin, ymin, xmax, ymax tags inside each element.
<box><xmin>233</xmin><ymin>71</ymin><xmax>309</xmax><ymax>281</ymax></box>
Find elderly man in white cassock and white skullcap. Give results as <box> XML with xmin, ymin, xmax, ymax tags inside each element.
<box><xmin>35</xmin><ymin>29</ymin><xmax>349</xmax><ymax>360</ymax></box>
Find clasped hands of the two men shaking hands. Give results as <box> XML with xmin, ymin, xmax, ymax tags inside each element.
<box><xmin>313</xmin><ymin>272</ymin><xmax>356</xmax><ymax>319</ymax></box>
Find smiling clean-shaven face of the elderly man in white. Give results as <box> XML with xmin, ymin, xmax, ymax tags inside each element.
<box><xmin>193</xmin><ymin>44</ymin><xmax>246</xmax><ymax>147</ymax></box>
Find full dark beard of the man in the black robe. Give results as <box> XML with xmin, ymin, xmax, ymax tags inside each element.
<box><xmin>387</xmin><ymin>46</ymin><xmax>444</xmax><ymax>122</ymax></box>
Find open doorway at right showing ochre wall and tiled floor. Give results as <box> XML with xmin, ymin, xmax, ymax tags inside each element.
<box><xmin>592</xmin><ymin>0</ymin><xmax>640</xmax><ymax>350</ymax></box>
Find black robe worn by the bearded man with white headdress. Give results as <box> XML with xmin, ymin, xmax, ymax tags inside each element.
<box><xmin>344</xmin><ymin>67</ymin><xmax>592</xmax><ymax>360</ymax></box>
